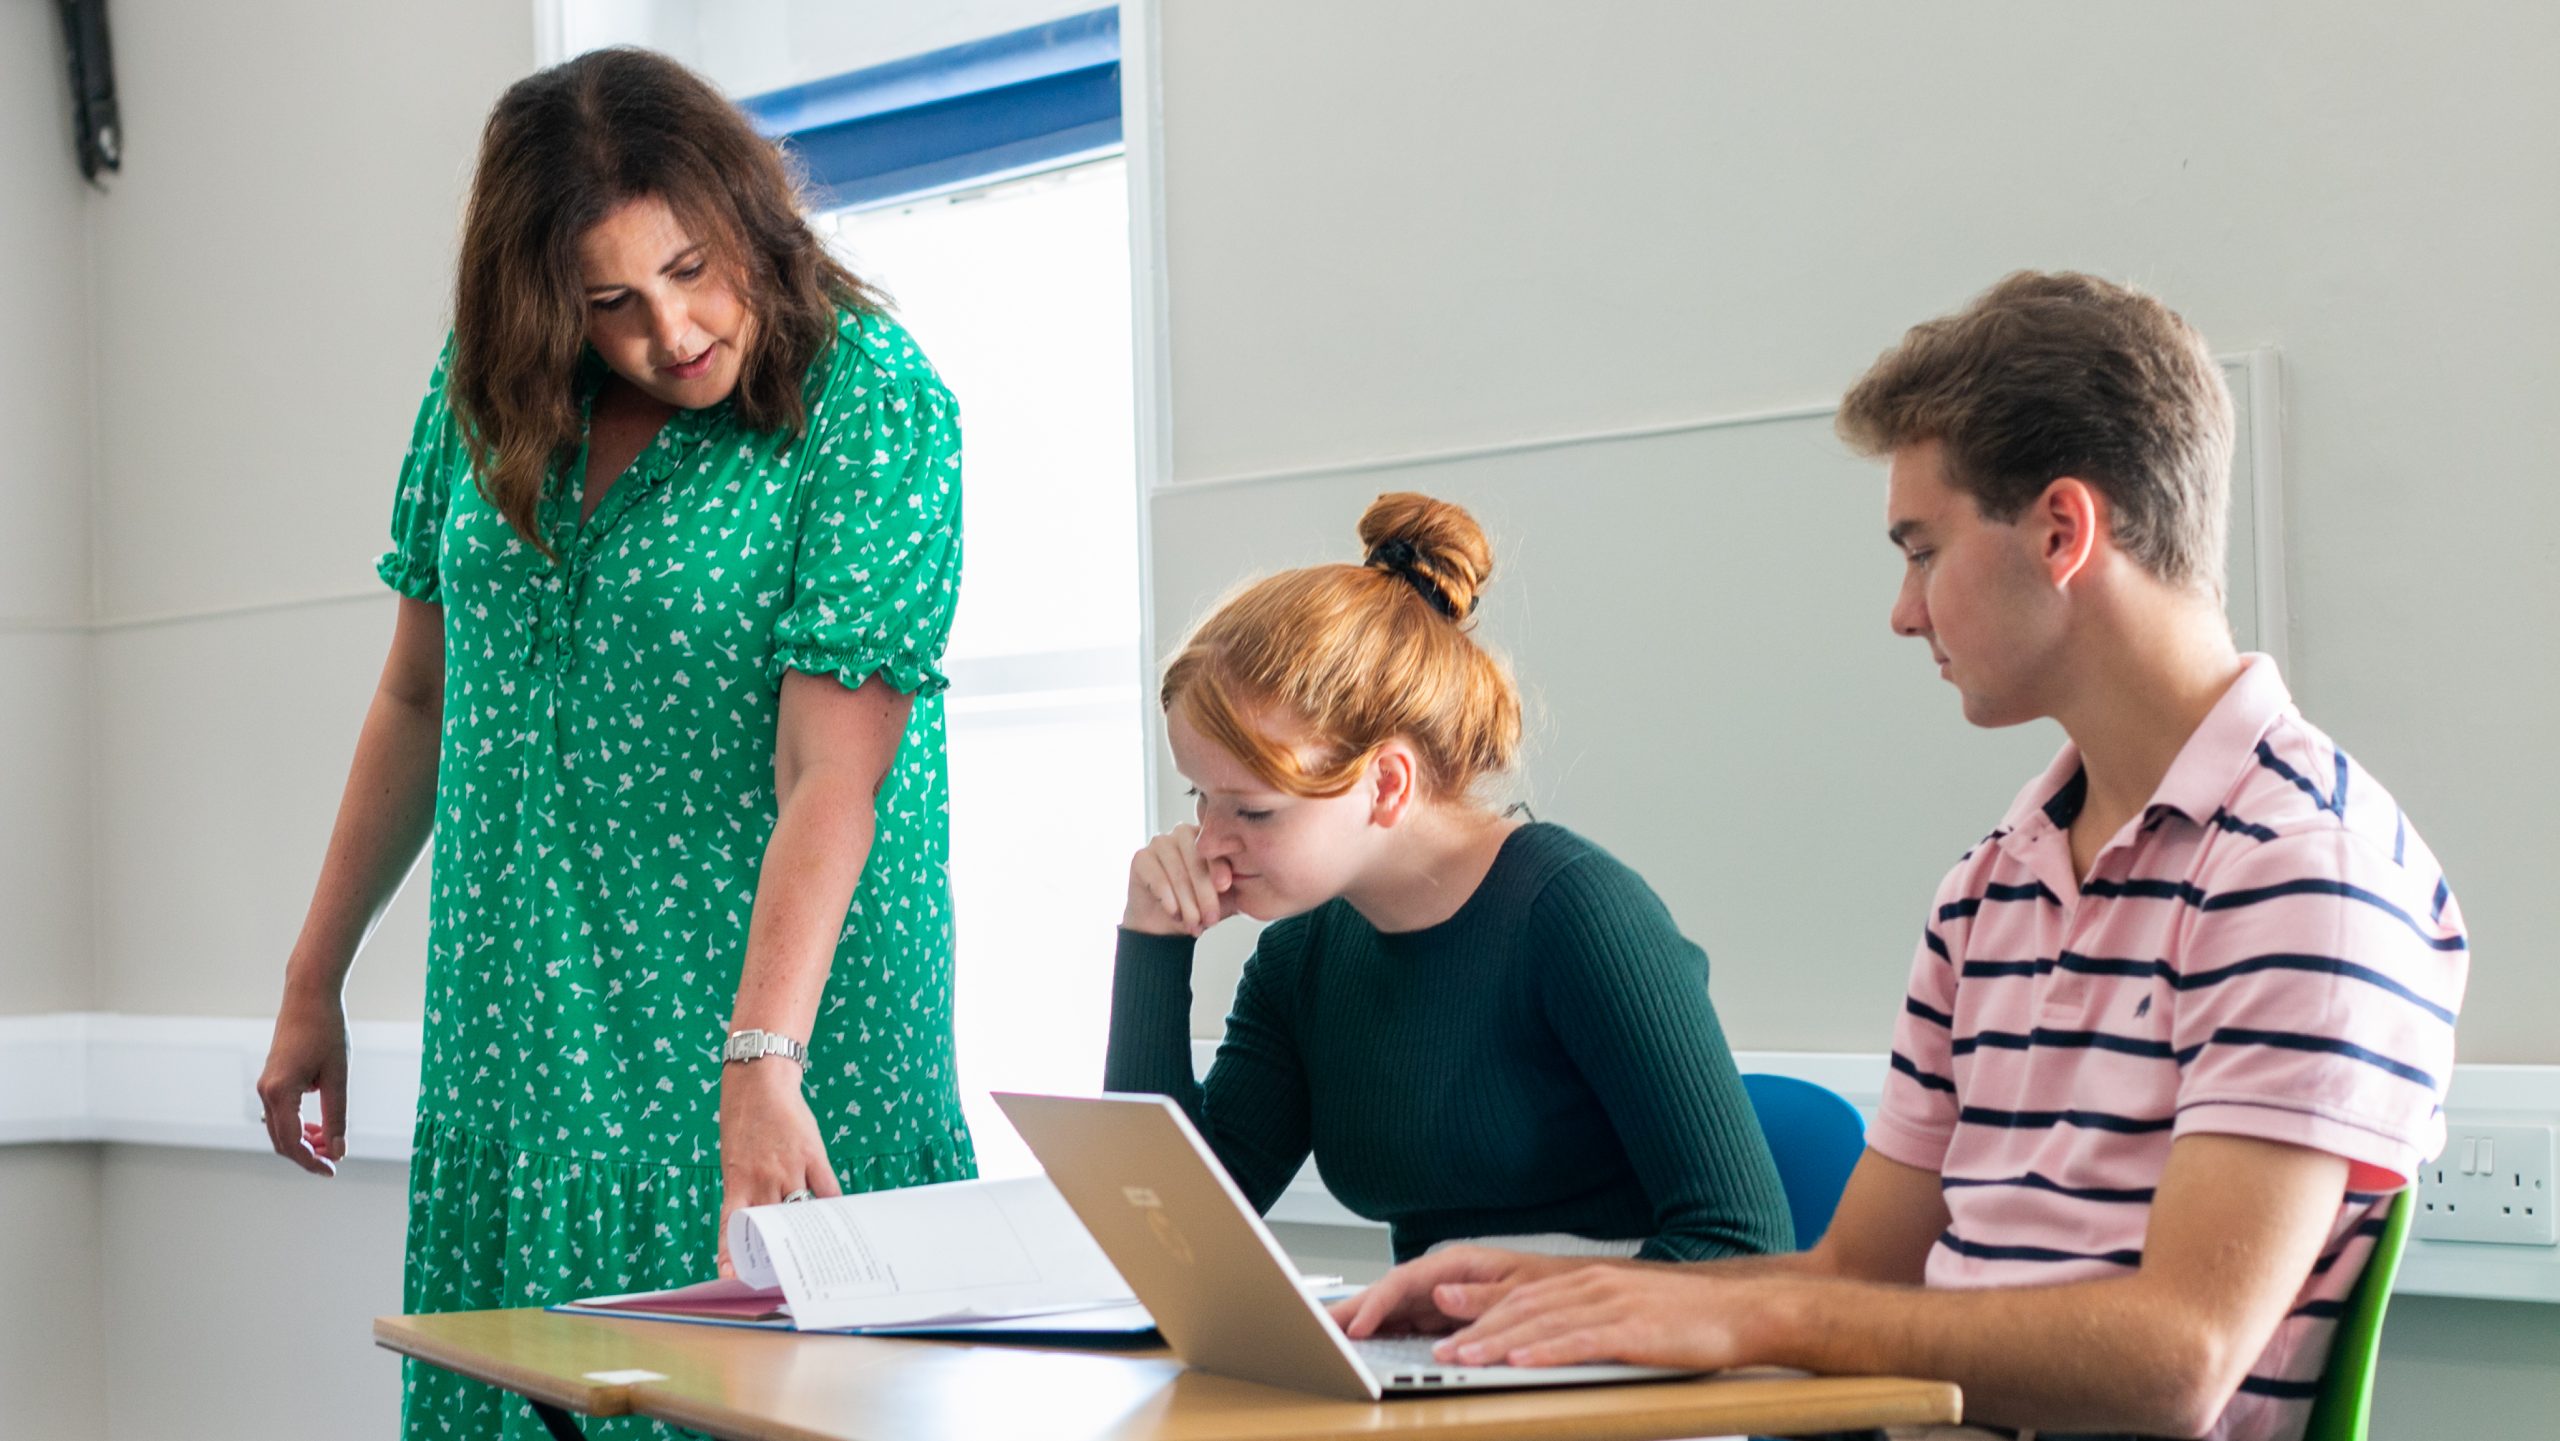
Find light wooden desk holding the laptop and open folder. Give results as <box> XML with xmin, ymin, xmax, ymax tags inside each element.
<box><xmin>374</xmin><ymin>1310</ymin><xmax>1961</xmax><ymax>1441</ymax></box>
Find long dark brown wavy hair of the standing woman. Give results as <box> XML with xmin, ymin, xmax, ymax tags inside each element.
<box><xmin>445</xmin><ymin>49</ymin><xmax>886</xmax><ymax>558</ymax></box>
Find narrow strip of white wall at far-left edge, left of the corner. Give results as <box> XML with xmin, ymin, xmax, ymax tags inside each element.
<box><xmin>0</xmin><ymin>0</ymin><xmax>105</xmax><ymax>1438</ymax></box>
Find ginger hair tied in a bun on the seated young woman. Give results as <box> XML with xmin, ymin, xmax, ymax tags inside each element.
<box><xmin>1160</xmin><ymin>491</ymin><xmax>1521</xmax><ymax>799</ymax></box>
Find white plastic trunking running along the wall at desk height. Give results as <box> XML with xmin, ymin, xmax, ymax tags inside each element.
<box><xmin>0</xmin><ymin>1011</ymin><xmax>2560</xmax><ymax>1303</ymax></box>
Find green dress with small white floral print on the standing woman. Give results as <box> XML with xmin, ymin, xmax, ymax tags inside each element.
<box><xmin>379</xmin><ymin>315</ymin><xmax>975</xmax><ymax>1438</ymax></box>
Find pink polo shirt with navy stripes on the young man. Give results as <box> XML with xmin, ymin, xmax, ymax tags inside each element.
<box><xmin>1869</xmin><ymin>655</ymin><xmax>2468</xmax><ymax>1441</ymax></box>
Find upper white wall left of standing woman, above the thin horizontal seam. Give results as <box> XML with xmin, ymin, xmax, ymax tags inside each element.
<box><xmin>95</xmin><ymin>0</ymin><xmax>509</xmax><ymax>622</ymax></box>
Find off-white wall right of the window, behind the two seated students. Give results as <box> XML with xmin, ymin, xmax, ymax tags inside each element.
<box><xmin>1149</xmin><ymin>0</ymin><xmax>2560</xmax><ymax>1436</ymax></box>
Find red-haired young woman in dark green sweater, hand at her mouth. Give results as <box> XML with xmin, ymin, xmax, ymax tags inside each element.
<box><xmin>1106</xmin><ymin>494</ymin><xmax>1792</xmax><ymax>1259</ymax></box>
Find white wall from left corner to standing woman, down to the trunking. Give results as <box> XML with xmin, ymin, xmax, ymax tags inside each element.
<box><xmin>92</xmin><ymin>0</ymin><xmax>532</xmax><ymax>1019</ymax></box>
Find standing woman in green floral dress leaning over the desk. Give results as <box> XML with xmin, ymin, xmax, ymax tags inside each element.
<box><xmin>259</xmin><ymin>51</ymin><xmax>973</xmax><ymax>1438</ymax></box>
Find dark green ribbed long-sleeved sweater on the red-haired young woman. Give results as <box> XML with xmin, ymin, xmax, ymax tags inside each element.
<box><xmin>1103</xmin><ymin>824</ymin><xmax>1792</xmax><ymax>1259</ymax></box>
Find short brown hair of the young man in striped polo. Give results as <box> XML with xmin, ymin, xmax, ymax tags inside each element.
<box><xmin>1838</xmin><ymin>271</ymin><xmax>2232</xmax><ymax>596</ymax></box>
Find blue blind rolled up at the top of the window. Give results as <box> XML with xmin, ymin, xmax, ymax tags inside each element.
<box><xmin>737</xmin><ymin>5</ymin><xmax>1121</xmax><ymax>205</ymax></box>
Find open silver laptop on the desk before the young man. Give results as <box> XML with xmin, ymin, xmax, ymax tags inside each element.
<box><xmin>996</xmin><ymin>1090</ymin><xmax>1695</xmax><ymax>1400</ymax></box>
